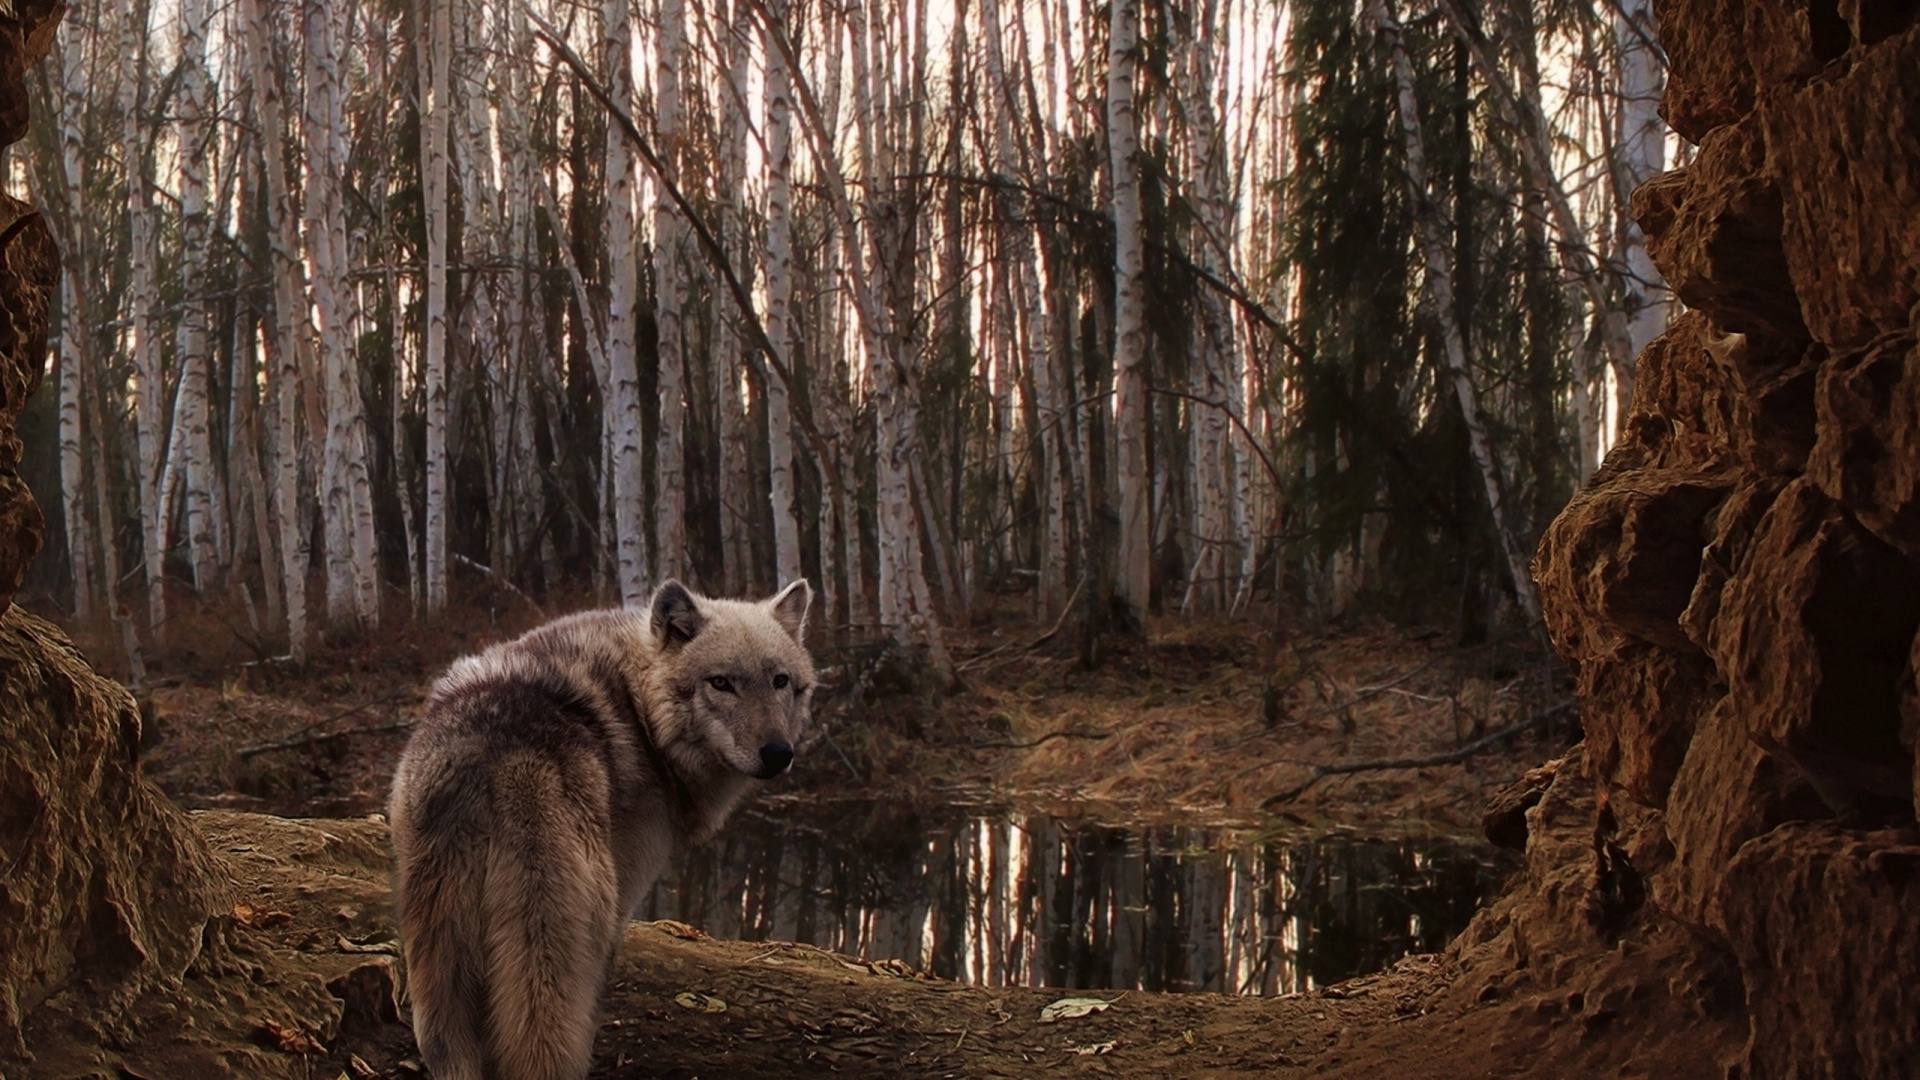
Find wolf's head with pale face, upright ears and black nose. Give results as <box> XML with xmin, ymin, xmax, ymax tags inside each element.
<box><xmin>647</xmin><ymin>580</ymin><xmax>814</xmax><ymax>780</ymax></box>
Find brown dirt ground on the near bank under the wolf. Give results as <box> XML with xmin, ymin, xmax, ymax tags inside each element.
<box><xmin>15</xmin><ymin>811</ymin><xmax>1728</xmax><ymax>1080</ymax></box>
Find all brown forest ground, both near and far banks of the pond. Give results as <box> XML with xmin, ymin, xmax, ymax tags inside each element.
<box><xmin>29</xmin><ymin>599</ymin><xmax>1681</xmax><ymax>1080</ymax></box>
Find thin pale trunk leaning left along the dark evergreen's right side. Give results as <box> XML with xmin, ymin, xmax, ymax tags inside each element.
<box><xmin>1367</xmin><ymin>0</ymin><xmax>1540</xmax><ymax>625</ymax></box>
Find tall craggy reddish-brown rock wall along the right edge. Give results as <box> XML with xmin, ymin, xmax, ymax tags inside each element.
<box><xmin>1528</xmin><ymin>0</ymin><xmax>1920</xmax><ymax>1078</ymax></box>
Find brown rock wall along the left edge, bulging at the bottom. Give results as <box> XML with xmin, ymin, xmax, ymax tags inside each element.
<box><xmin>0</xmin><ymin>0</ymin><xmax>221</xmax><ymax>1074</ymax></box>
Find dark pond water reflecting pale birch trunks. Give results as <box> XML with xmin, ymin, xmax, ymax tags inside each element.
<box><xmin>639</xmin><ymin>803</ymin><xmax>1513</xmax><ymax>994</ymax></box>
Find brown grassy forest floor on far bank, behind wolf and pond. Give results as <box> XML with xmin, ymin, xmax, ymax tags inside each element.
<box><xmin>120</xmin><ymin>595</ymin><xmax>1578</xmax><ymax>836</ymax></box>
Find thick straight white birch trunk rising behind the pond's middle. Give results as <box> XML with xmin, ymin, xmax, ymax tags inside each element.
<box><xmin>1106</xmin><ymin>0</ymin><xmax>1154</xmax><ymax>626</ymax></box>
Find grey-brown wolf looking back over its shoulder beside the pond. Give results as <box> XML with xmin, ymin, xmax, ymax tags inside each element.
<box><xmin>388</xmin><ymin>580</ymin><xmax>814</xmax><ymax>1080</ymax></box>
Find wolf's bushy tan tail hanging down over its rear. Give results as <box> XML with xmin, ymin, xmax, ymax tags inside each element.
<box><xmin>482</xmin><ymin>755</ymin><xmax>622</xmax><ymax>1080</ymax></box>
